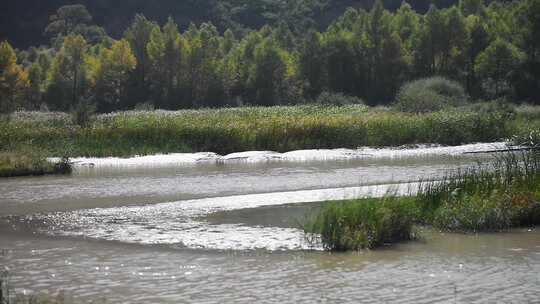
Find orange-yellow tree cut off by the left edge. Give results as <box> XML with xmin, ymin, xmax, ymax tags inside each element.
<box><xmin>0</xmin><ymin>41</ymin><xmax>28</xmax><ymax>112</ymax></box>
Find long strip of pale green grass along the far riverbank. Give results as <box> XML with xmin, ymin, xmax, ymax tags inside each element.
<box><xmin>0</xmin><ymin>105</ymin><xmax>524</xmax><ymax>157</ymax></box>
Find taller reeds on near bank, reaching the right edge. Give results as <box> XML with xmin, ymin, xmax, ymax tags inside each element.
<box><xmin>417</xmin><ymin>150</ymin><xmax>540</xmax><ymax>232</ymax></box>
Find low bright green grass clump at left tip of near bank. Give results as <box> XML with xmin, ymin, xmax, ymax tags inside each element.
<box><xmin>304</xmin><ymin>197</ymin><xmax>416</xmax><ymax>251</ymax></box>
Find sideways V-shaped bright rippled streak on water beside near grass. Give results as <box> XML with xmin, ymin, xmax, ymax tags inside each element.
<box><xmin>32</xmin><ymin>183</ymin><xmax>418</xmax><ymax>250</ymax></box>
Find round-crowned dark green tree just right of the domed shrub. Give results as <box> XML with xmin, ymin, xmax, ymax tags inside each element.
<box><xmin>475</xmin><ymin>39</ymin><xmax>524</xmax><ymax>97</ymax></box>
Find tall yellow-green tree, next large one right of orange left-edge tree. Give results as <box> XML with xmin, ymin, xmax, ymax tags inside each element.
<box><xmin>47</xmin><ymin>35</ymin><xmax>88</xmax><ymax>110</ymax></box>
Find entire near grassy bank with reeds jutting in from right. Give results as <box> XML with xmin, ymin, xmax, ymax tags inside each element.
<box><xmin>304</xmin><ymin>151</ymin><xmax>540</xmax><ymax>251</ymax></box>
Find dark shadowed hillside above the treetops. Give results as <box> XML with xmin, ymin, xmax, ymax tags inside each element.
<box><xmin>0</xmin><ymin>0</ymin><xmax>458</xmax><ymax>48</ymax></box>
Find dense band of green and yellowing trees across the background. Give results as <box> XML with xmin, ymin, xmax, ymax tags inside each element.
<box><xmin>0</xmin><ymin>0</ymin><xmax>540</xmax><ymax>112</ymax></box>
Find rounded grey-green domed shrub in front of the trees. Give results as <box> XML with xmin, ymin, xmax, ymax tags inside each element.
<box><xmin>394</xmin><ymin>77</ymin><xmax>467</xmax><ymax>113</ymax></box>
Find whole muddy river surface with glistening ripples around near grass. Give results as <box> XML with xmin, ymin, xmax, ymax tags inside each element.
<box><xmin>0</xmin><ymin>143</ymin><xmax>540</xmax><ymax>303</ymax></box>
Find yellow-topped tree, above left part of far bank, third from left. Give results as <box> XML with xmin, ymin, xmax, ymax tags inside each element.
<box><xmin>92</xmin><ymin>40</ymin><xmax>137</xmax><ymax>112</ymax></box>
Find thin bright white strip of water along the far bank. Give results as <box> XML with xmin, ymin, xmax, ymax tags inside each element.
<box><xmin>49</xmin><ymin>142</ymin><xmax>507</xmax><ymax>168</ymax></box>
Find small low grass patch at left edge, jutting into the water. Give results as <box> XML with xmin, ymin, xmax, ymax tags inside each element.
<box><xmin>0</xmin><ymin>151</ymin><xmax>71</xmax><ymax>177</ymax></box>
